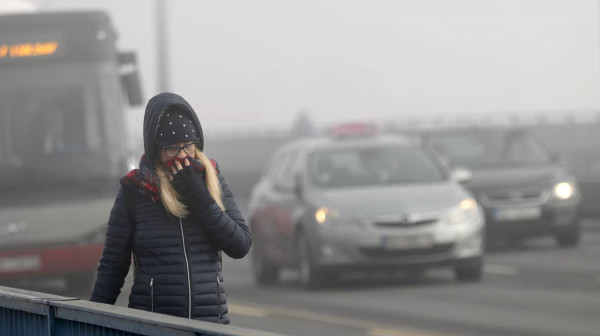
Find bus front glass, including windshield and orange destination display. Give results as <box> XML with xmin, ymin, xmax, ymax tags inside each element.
<box><xmin>0</xmin><ymin>12</ymin><xmax>127</xmax><ymax>191</ymax></box>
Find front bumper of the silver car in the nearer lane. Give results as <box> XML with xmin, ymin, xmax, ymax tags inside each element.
<box><xmin>312</xmin><ymin>221</ymin><xmax>484</xmax><ymax>268</ymax></box>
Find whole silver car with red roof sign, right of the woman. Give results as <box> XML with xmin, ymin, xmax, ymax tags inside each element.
<box><xmin>249</xmin><ymin>135</ymin><xmax>485</xmax><ymax>286</ymax></box>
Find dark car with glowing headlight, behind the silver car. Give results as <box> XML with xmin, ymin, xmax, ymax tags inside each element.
<box><xmin>423</xmin><ymin>128</ymin><xmax>582</xmax><ymax>247</ymax></box>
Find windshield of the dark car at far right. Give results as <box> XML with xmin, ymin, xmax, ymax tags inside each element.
<box><xmin>429</xmin><ymin>131</ymin><xmax>551</xmax><ymax>169</ymax></box>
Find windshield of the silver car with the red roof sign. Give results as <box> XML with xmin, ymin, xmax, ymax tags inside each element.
<box><xmin>309</xmin><ymin>147</ymin><xmax>444</xmax><ymax>188</ymax></box>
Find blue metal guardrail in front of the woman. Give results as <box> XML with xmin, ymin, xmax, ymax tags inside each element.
<box><xmin>0</xmin><ymin>286</ymin><xmax>284</xmax><ymax>336</ymax></box>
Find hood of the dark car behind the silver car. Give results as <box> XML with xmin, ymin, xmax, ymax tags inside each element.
<box><xmin>464</xmin><ymin>166</ymin><xmax>569</xmax><ymax>195</ymax></box>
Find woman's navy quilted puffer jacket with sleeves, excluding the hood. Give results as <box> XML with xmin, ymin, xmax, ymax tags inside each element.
<box><xmin>91</xmin><ymin>92</ymin><xmax>252</xmax><ymax>324</ymax></box>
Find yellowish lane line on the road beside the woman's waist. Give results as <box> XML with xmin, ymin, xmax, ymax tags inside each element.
<box><xmin>228</xmin><ymin>304</ymin><xmax>449</xmax><ymax>336</ymax></box>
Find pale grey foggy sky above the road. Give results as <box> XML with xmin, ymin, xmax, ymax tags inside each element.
<box><xmin>32</xmin><ymin>0</ymin><xmax>600</xmax><ymax>132</ymax></box>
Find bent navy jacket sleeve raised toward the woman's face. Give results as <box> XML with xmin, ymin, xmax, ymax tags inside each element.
<box><xmin>190</xmin><ymin>169</ymin><xmax>252</xmax><ymax>259</ymax></box>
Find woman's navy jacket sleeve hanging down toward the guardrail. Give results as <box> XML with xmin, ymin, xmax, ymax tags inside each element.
<box><xmin>90</xmin><ymin>188</ymin><xmax>134</xmax><ymax>304</ymax></box>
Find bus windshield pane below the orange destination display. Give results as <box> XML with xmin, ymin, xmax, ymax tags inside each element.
<box><xmin>0</xmin><ymin>70</ymin><xmax>126</xmax><ymax>188</ymax></box>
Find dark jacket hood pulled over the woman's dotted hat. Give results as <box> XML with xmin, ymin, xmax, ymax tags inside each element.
<box><xmin>144</xmin><ymin>92</ymin><xmax>204</xmax><ymax>164</ymax></box>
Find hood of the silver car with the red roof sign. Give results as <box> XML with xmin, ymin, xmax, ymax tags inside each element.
<box><xmin>307</xmin><ymin>182</ymin><xmax>471</xmax><ymax>216</ymax></box>
